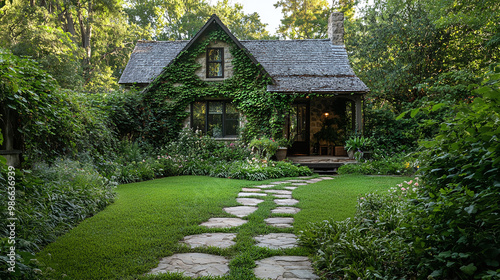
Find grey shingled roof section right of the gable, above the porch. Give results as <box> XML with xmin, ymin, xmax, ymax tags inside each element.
<box><xmin>241</xmin><ymin>40</ymin><xmax>369</xmax><ymax>93</ymax></box>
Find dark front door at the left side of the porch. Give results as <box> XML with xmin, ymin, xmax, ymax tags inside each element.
<box><xmin>287</xmin><ymin>102</ymin><xmax>310</xmax><ymax>155</ymax></box>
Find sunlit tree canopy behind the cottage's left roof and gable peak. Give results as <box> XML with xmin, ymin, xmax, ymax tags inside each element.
<box><xmin>0</xmin><ymin>0</ymin><xmax>270</xmax><ymax>92</ymax></box>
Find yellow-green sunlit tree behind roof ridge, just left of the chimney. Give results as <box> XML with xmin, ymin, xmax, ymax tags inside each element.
<box><xmin>274</xmin><ymin>0</ymin><xmax>332</xmax><ymax>39</ymax></box>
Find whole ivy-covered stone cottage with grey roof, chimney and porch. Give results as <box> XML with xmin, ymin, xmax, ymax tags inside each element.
<box><xmin>119</xmin><ymin>13</ymin><xmax>369</xmax><ymax>158</ymax></box>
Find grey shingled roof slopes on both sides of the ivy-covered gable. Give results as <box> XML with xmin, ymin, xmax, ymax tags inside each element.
<box><xmin>119</xmin><ymin>15</ymin><xmax>369</xmax><ymax>93</ymax></box>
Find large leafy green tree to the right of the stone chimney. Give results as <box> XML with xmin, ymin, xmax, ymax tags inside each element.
<box><xmin>346</xmin><ymin>0</ymin><xmax>499</xmax><ymax>111</ymax></box>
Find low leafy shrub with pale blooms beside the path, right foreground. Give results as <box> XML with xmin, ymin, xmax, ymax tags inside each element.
<box><xmin>299</xmin><ymin>181</ymin><xmax>418</xmax><ymax>279</ymax></box>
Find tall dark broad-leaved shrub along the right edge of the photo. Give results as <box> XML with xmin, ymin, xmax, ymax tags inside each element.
<box><xmin>406</xmin><ymin>66</ymin><xmax>500</xmax><ymax>279</ymax></box>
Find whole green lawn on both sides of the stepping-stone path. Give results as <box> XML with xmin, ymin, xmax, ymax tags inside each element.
<box><xmin>37</xmin><ymin>176</ymin><xmax>407</xmax><ymax>280</ymax></box>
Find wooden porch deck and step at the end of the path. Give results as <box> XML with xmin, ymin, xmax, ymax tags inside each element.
<box><xmin>287</xmin><ymin>156</ymin><xmax>356</xmax><ymax>174</ymax></box>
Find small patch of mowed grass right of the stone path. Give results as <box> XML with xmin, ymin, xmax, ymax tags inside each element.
<box><xmin>293</xmin><ymin>175</ymin><xmax>411</xmax><ymax>231</ymax></box>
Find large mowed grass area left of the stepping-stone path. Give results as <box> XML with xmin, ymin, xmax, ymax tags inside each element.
<box><xmin>37</xmin><ymin>176</ymin><xmax>253</xmax><ymax>279</ymax></box>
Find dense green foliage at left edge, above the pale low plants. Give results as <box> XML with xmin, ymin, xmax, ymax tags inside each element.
<box><xmin>0</xmin><ymin>51</ymin><xmax>115</xmax><ymax>162</ymax></box>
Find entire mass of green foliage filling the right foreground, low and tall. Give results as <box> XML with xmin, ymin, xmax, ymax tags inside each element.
<box><xmin>301</xmin><ymin>66</ymin><xmax>500</xmax><ymax>279</ymax></box>
